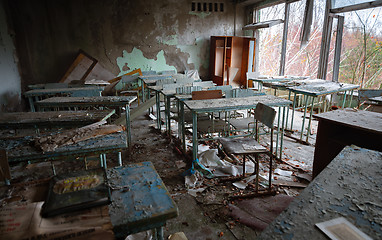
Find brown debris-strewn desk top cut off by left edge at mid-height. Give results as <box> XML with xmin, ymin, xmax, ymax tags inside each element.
<box><xmin>0</xmin><ymin>109</ymin><xmax>115</xmax><ymax>128</ymax></box>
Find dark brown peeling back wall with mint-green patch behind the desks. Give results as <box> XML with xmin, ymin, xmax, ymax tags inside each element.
<box><xmin>7</xmin><ymin>0</ymin><xmax>245</xmax><ymax>89</ymax></box>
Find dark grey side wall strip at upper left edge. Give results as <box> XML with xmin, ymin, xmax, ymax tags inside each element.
<box><xmin>0</xmin><ymin>0</ymin><xmax>21</xmax><ymax>112</ymax></box>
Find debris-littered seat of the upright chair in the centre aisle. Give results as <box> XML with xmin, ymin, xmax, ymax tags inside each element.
<box><xmin>219</xmin><ymin>137</ymin><xmax>268</xmax><ymax>154</ymax></box>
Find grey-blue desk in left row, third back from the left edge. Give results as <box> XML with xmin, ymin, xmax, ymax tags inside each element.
<box><xmin>24</xmin><ymin>87</ymin><xmax>104</xmax><ymax>112</ymax></box>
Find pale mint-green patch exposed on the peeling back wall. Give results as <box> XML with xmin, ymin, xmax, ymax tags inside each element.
<box><xmin>116</xmin><ymin>47</ymin><xmax>177</xmax><ymax>76</ymax></box>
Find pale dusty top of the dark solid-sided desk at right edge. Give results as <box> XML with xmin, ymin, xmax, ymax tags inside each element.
<box><xmin>313</xmin><ymin>109</ymin><xmax>382</xmax><ymax>134</ymax></box>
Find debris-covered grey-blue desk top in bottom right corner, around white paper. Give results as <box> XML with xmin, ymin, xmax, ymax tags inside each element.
<box><xmin>256</xmin><ymin>146</ymin><xmax>382</xmax><ymax>240</ymax></box>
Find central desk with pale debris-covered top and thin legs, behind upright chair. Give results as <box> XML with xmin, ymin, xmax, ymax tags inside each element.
<box><xmin>181</xmin><ymin>95</ymin><xmax>291</xmax><ymax>160</ymax></box>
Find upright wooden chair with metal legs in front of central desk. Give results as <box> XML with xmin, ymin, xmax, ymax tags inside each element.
<box><xmin>219</xmin><ymin>103</ymin><xmax>276</xmax><ymax>195</ymax></box>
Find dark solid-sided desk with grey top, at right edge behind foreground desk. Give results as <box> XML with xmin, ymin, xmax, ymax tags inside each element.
<box><xmin>313</xmin><ymin>109</ymin><xmax>382</xmax><ymax>177</ymax></box>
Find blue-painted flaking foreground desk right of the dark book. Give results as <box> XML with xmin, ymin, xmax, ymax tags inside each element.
<box><xmin>107</xmin><ymin>162</ymin><xmax>178</xmax><ymax>240</ymax></box>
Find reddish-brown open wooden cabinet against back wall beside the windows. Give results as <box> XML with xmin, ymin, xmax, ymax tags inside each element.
<box><xmin>210</xmin><ymin>36</ymin><xmax>256</xmax><ymax>86</ymax></box>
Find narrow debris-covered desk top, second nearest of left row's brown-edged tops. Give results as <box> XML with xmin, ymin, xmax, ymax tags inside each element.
<box><xmin>36</xmin><ymin>96</ymin><xmax>137</xmax><ymax>106</ymax></box>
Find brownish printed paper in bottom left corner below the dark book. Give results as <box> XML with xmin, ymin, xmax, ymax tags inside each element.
<box><xmin>0</xmin><ymin>202</ymin><xmax>114</xmax><ymax>240</ymax></box>
